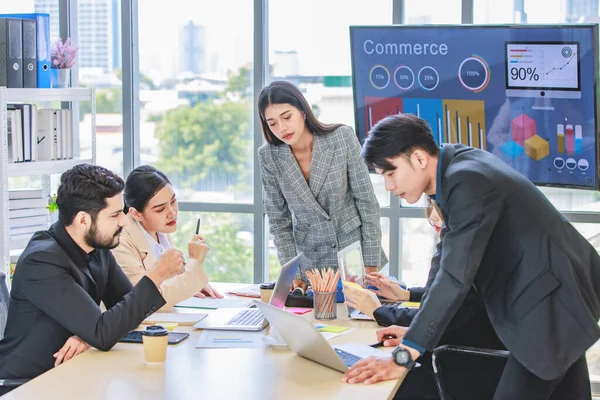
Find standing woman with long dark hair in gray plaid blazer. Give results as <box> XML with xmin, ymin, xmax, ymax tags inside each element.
<box><xmin>258</xmin><ymin>81</ymin><xmax>387</xmax><ymax>288</ymax></box>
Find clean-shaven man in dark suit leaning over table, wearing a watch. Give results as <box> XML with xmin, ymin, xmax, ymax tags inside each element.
<box><xmin>344</xmin><ymin>114</ymin><xmax>600</xmax><ymax>400</ymax></box>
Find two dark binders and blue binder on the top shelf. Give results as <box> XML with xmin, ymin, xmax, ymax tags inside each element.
<box><xmin>0</xmin><ymin>13</ymin><xmax>52</xmax><ymax>88</ymax></box>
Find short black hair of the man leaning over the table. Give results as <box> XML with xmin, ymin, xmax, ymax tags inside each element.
<box><xmin>361</xmin><ymin>114</ymin><xmax>439</xmax><ymax>172</ymax></box>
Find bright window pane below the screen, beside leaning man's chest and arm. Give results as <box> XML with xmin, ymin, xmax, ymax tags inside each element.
<box><xmin>400</xmin><ymin>218</ymin><xmax>438</xmax><ymax>287</ymax></box>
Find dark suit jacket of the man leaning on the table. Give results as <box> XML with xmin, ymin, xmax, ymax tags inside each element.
<box><xmin>405</xmin><ymin>144</ymin><xmax>600</xmax><ymax>380</ymax></box>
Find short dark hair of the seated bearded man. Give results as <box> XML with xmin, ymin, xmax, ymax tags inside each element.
<box><xmin>56</xmin><ymin>164</ymin><xmax>125</xmax><ymax>226</ymax></box>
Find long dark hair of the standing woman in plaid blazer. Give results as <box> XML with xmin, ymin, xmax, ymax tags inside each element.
<box><xmin>258</xmin><ymin>81</ymin><xmax>342</xmax><ymax>146</ymax></box>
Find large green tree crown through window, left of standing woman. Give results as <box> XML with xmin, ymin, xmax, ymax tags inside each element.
<box><xmin>155</xmin><ymin>101</ymin><xmax>252</xmax><ymax>189</ymax></box>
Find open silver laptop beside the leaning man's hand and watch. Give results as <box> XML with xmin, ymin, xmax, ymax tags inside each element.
<box><xmin>254</xmin><ymin>300</ymin><xmax>390</xmax><ymax>372</ymax></box>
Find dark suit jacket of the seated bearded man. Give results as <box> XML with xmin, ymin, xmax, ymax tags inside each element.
<box><xmin>0</xmin><ymin>222</ymin><xmax>165</xmax><ymax>378</ymax></box>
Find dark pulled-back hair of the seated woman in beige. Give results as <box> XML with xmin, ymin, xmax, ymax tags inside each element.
<box><xmin>123</xmin><ymin>165</ymin><xmax>171</xmax><ymax>214</ymax></box>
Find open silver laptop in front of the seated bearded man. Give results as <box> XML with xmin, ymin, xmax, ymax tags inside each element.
<box><xmin>194</xmin><ymin>253</ymin><xmax>303</xmax><ymax>331</ymax></box>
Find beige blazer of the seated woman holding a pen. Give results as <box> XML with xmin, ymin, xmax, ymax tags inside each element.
<box><xmin>112</xmin><ymin>215</ymin><xmax>208</xmax><ymax>311</ymax></box>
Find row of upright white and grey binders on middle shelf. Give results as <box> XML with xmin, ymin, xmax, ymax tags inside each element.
<box><xmin>7</xmin><ymin>104</ymin><xmax>73</xmax><ymax>163</ymax></box>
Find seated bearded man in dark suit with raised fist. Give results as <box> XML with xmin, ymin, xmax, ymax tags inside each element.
<box><xmin>0</xmin><ymin>164</ymin><xmax>195</xmax><ymax>390</ymax></box>
